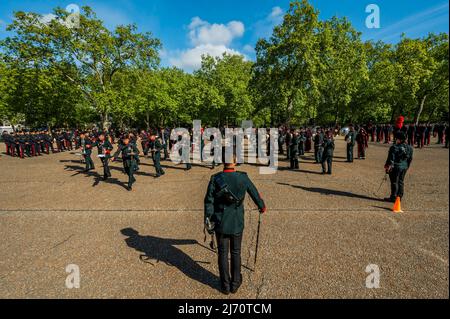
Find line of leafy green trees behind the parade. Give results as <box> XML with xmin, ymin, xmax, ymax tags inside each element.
<box><xmin>0</xmin><ymin>0</ymin><xmax>449</xmax><ymax>128</ymax></box>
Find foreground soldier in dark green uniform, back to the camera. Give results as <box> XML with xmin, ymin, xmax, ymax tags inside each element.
<box><xmin>205</xmin><ymin>159</ymin><xmax>266</xmax><ymax>295</ymax></box>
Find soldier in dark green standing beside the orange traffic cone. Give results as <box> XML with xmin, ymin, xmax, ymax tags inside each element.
<box><xmin>384</xmin><ymin>132</ymin><xmax>414</xmax><ymax>203</ymax></box>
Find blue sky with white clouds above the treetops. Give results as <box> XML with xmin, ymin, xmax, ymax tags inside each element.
<box><xmin>0</xmin><ymin>0</ymin><xmax>449</xmax><ymax>71</ymax></box>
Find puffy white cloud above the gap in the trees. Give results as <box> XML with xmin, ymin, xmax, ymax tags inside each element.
<box><xmin>169</xmin><ymin>17</ymin><xmax>245</xmax><ymax>71</ymax></box>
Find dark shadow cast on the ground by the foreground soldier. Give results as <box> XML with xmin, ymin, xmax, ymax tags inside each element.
<box><xmin>121</xmin><ymin>228</ymin><xmax>219</xmax><ymax>290</ymax></box>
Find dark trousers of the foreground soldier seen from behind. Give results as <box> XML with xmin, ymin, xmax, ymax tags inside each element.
<box><xmin>216</xmin><ymin>233</ymin><xmax>242</xmax><ymax>291</ymax></box>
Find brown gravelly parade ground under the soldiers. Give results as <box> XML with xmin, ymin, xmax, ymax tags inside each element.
<box><xmin>0</xmin><ymin>140</ymin><xmax>449</xmax><ymax>298</ymax></box>
